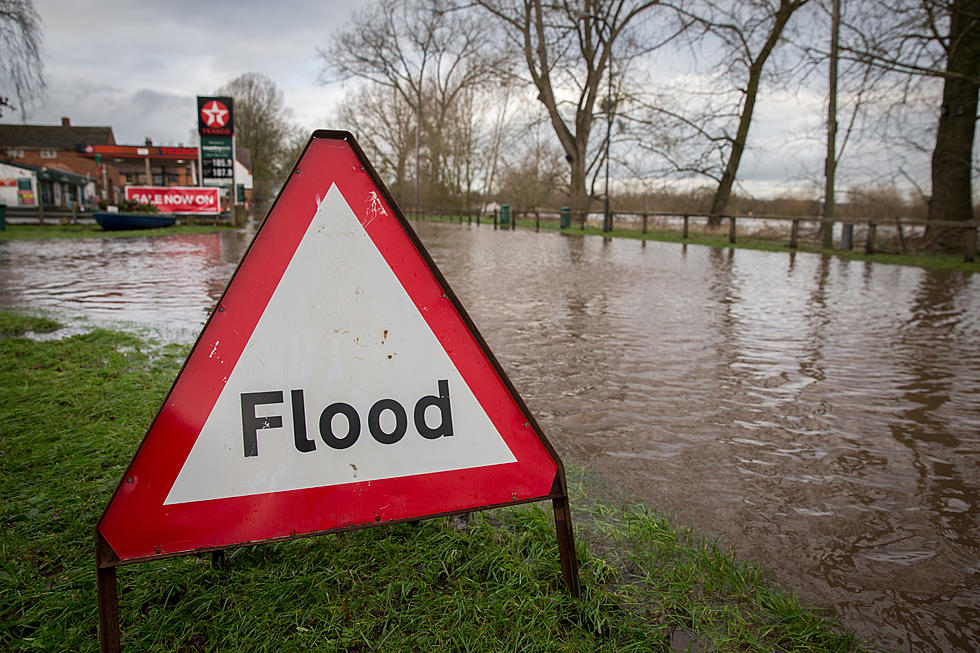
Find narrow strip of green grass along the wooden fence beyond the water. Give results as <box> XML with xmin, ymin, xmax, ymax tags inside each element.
<box><xmin>420</xmin><ymin>216</ymin><xmax>980</xmax><ymax>272</ymax></box>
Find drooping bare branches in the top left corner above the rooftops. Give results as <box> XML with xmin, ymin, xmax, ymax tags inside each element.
<box><xmin>0</xmin><ymin>0</ymin><xmax>44</xmax><ymax>121</ymax></box>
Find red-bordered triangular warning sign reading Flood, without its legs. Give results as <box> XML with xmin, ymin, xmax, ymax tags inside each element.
<box><xmin>97</xmin><ymin>131</ymin><xmax>564</xmax><ymax>562</ymax></box>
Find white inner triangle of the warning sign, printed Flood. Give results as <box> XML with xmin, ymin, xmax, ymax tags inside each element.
<box><xmin>165</xmin><ymin>184</ymin><xmax>516</xmax><ymax>505</ymax></box>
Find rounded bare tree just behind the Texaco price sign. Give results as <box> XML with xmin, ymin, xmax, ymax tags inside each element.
<box><xmin>216</xmin><ymin>73</ymin><xmax>295</xmax><ymax>202</ymax></box>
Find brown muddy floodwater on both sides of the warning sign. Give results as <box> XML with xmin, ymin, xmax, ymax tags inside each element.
<box><xmin>0</xmin><ymin>223</ymin><xmax>980</xmax><ymax>651</ymax></box>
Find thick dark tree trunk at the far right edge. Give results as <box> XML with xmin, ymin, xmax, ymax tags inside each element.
<box><xmin>928</xmin><ymin>0</ymin><xmax>980</xmax><ymax>250</ymax></box>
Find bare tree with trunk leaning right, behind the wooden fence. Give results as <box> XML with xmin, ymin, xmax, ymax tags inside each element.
<box><xmin>624</xmin><ymin>0</ymin><xmax>886</xmax><ymax>223</ymax></box>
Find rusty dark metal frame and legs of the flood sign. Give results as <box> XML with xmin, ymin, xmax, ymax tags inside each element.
<box><xmin>95</xmin><ymin>130</ymin><xmax>579</xmax><ymax>651</ymax></box>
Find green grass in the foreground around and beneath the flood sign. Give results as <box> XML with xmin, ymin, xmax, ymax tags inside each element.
<box><xmin>0</xmin><ymin>314</ymin><xmax>872</xmax><ymax>653</ymax></box>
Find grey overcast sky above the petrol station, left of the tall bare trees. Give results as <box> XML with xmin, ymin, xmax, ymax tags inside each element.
<box><xmin>28</xmin><ymin>0</ymin><xmax>359</xmax><ymax>145</ymax></box>
